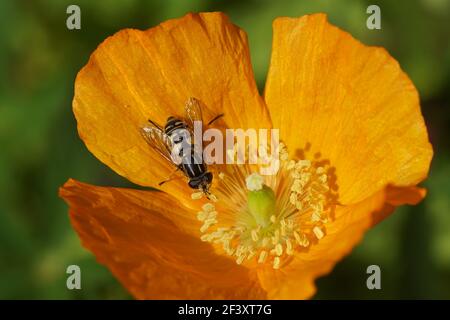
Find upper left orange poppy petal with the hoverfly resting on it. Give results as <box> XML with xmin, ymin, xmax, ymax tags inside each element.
<box><xmin>73</xmin><ymin>13</ymin><xmax>270</xmax><ymax>200</ymax></box>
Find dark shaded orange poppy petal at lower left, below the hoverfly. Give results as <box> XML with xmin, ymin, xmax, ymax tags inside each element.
<box><xmin>60</xmin><ymin>180</ymin><xmax>265</xmax><ymax>299</ymax></box>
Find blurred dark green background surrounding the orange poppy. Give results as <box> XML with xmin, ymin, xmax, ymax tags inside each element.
<box><xmin>0</xmin><ymin>0</ymin><xmax>450</xmax><ymax>299</ymax></box>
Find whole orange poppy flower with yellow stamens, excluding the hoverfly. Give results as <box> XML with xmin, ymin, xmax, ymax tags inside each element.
<box><xmin>60</xmin><ymin>13</ymin><xmax>432</xmax><ymax>299</ymax></box>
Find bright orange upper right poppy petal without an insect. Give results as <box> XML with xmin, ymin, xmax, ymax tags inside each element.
<box><xmin>265</xmin><ymin>14</ymin><xmax>433</xmax><ymax>204</ymax></box>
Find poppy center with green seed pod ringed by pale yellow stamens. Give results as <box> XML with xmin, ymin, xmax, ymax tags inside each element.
<box><xmin>197</xmin><ymin>145</ymin><xmax>336</xmax><ymax>269</ymax></box>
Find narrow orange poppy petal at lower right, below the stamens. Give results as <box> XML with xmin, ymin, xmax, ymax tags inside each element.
<box><xmin>258</xmin><ymin>191</ymin><xmax>395</xmax><ymax>299</ymax></box>
